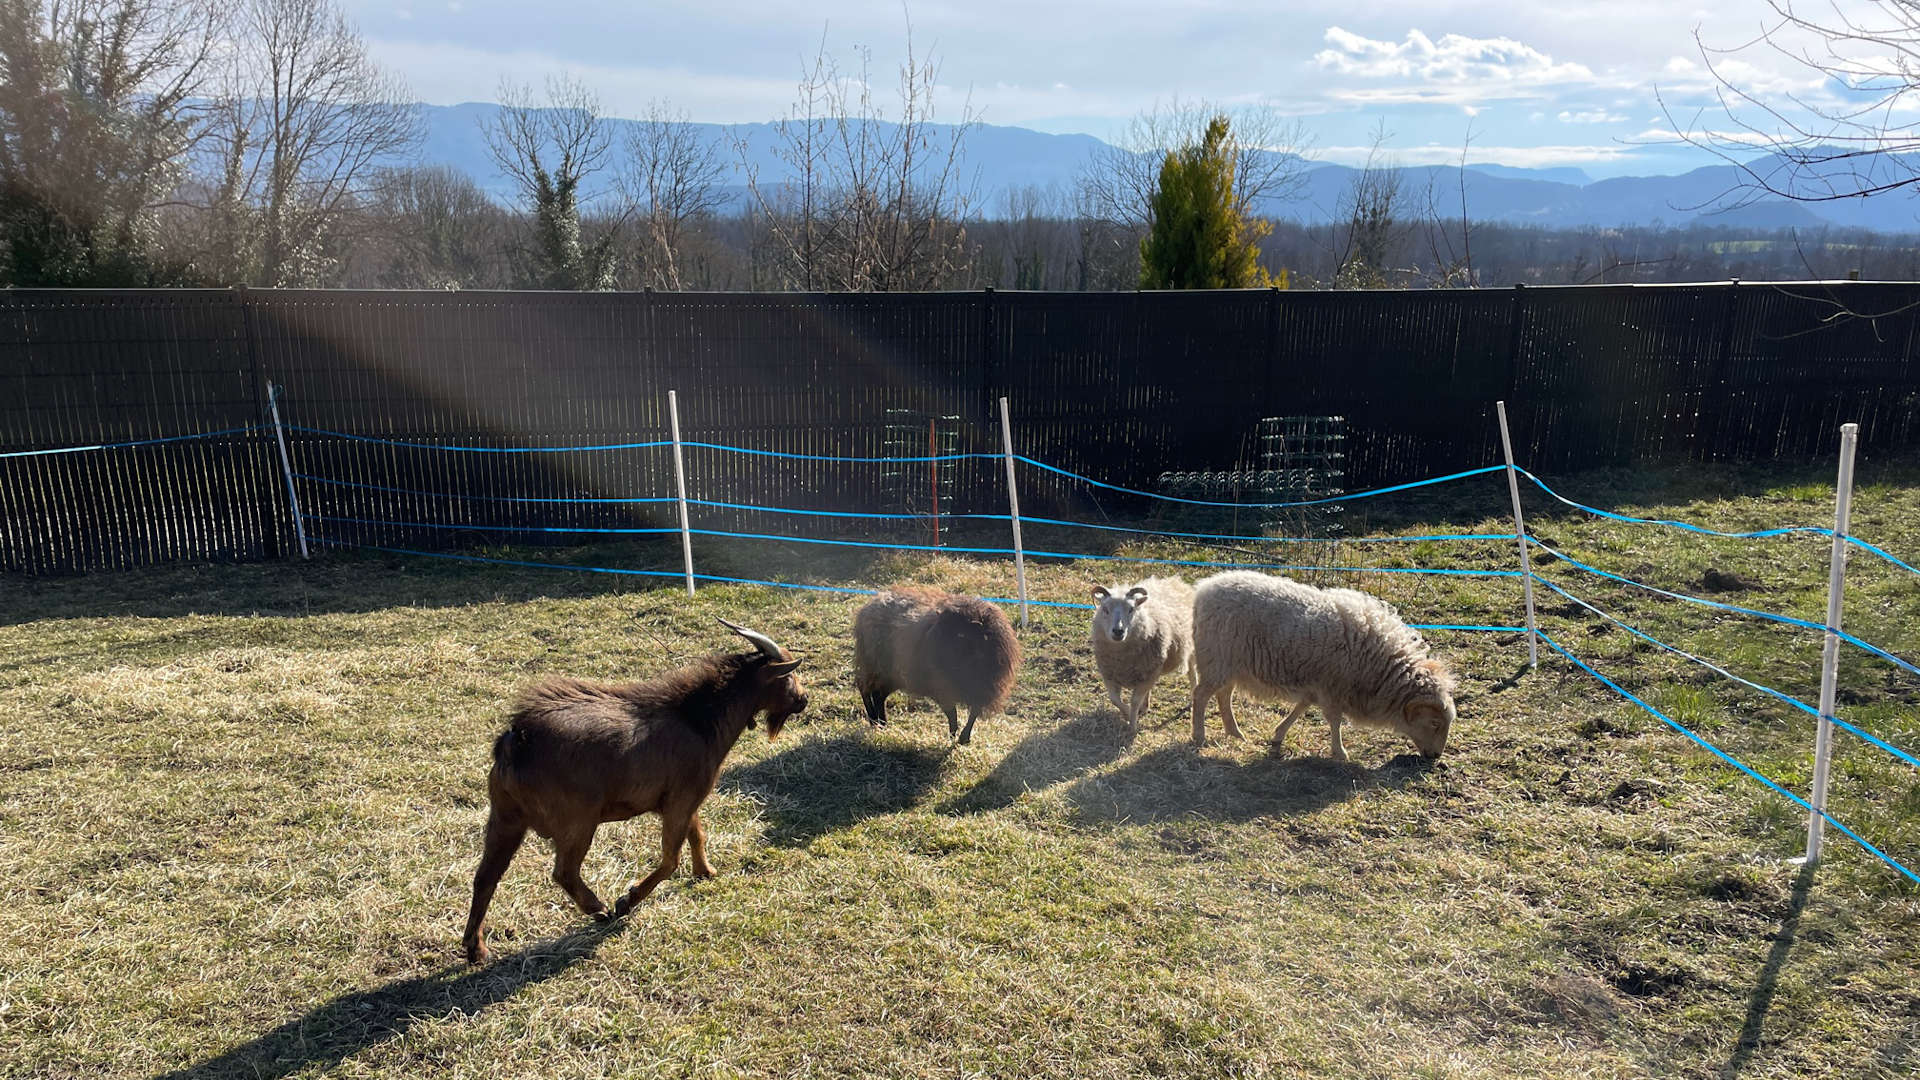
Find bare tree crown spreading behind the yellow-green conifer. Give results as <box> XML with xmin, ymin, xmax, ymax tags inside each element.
<box><xmin>1077</xmin><ymin>98</ymin><xmax>1309</xmax><ymax>229</ymax></box>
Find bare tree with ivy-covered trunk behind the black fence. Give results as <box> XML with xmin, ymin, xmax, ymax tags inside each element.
<box><xmin>482</xmin><ymin>77</ymin><xmax>620</xmax><ymax>290</ymax></box>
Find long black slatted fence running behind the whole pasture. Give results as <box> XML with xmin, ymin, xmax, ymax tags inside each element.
<box><xmin>0</xmin><ymin>282</ymin><xmax>1920</xmax><ymax>573</ymax></box>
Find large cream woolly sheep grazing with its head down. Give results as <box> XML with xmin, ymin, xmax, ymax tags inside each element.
<box><xmin>1194</xmin><ymin>571</ymin><xmax>1455</xmax><ymax>761</ymax></box>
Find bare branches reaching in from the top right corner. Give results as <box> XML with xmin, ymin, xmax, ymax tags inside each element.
<box><xmin>1661</xmin><ymin>0</ymin><xmax>1920</xmax><ymax>206</ymax></box>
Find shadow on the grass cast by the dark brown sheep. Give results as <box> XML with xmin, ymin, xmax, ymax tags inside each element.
<box><xmin>720</xmin><ymin>732</ymin><xmax>947</xmax><ymax>847</ymax></box>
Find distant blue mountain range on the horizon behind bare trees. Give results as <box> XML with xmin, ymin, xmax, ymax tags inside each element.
<box><xmin>420</xmin><ymin>104</ymin><xmax>1920</xmax><ymax>233</ymax></box>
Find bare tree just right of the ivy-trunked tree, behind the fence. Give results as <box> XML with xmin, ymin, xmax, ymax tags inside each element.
<box><xmin>620</xmin><ymin>102</ymin><xmax>728</xmax><ymax>288</ymax></box>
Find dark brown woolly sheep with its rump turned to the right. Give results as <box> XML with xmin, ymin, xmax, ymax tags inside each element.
<box><xmin>852</xmin><ymin>586</ymin><xmax>1020</xmax><ymax>744</ymax></box>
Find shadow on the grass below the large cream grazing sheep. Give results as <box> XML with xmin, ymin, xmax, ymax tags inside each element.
<box><xmin>1068</xmin><ymin>744</ymin><xmax>1440</xmax><ymax>822</ymax></box>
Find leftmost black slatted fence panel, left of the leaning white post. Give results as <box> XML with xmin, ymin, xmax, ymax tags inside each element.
<box><xmin>0</xmin><ymin>290</ymin><xmax>278</xmax><ymax>573</ymax></box>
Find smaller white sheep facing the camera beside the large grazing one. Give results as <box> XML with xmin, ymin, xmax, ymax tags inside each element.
<box><xmin>1092</xmin><ymin>578</ymin><xmax>1194</xmax><ymax>732</ymax></box>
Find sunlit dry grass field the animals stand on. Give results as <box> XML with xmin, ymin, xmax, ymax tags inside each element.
<box><xmin>0</xmin><ymin>457</ymin><xmax>1920</xmax><ymax>1078</ymax></box>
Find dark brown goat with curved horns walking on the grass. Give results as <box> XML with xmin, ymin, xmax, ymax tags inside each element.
<box><xmin>465</xmin><ymin>619</ymin><xmax>806</xmax><ymax>963</ymax></box>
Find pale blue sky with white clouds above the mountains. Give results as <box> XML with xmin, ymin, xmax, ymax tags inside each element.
<box><xmin>346</xmin><ymin>0</ymin><xmax>1820</xmax><ymax>177</ymax></box>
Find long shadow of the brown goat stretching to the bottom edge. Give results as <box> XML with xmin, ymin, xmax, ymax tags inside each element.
<box><xmin>157</xmin><ymin>920</ymin><xmax>626</xmax><ymax>1080</ymax></box>
